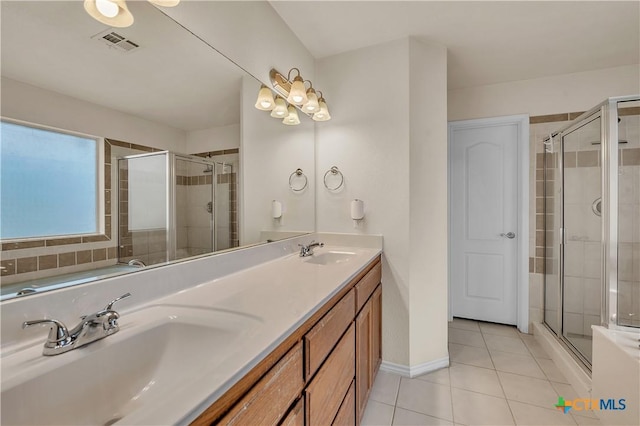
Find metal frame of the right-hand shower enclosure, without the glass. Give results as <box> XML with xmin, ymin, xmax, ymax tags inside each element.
<box><xmin>543</xmin><ymin>95</ymin><xmax>640</xmax><ymax>368</ymax></box>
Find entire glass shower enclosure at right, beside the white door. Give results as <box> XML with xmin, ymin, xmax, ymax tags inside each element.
<box><xmin>544</xmin><ymin>96</ymin><xmax>640</xmax><ymax>368</ymax></box>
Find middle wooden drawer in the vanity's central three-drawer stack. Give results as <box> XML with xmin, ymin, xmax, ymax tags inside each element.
<box><xmin>305</xmin><ymin>324</ymin><xmax>356</xmax><ymax>426</ymax></box>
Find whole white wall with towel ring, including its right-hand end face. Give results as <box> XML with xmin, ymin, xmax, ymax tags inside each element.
<box><xmin>316</xmin><ymin>39</ymin><xmax>447</xmax><ymax>367</ymax></box>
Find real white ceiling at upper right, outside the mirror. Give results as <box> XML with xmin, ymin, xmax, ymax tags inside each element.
<box><xmin>271</xmin><ymin>1</ymin><xmax>640</xmax><ymax>89</ymax></box>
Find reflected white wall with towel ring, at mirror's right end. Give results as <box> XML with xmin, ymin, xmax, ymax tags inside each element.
<box><xmin>240</xmin><ymin>76</ymin><xmax>316</xmax><ymax>245</ymax></box>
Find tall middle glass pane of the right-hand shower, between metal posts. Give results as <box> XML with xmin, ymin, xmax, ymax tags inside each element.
<box><xmin>561</xmin><ymin>113</ymin><xmax>603</xmax><ymax>364</ymax></box>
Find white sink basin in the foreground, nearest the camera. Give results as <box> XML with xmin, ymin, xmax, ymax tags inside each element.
<box><xmin>1</xmin><ymin>306</ymin><xmax>259</xmax><ymax>425</ymax></box>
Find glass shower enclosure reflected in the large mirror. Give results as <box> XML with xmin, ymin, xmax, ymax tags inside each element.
<box><xmin>117</xmin><ymin>151</ymin><xmax>235</xmax><ymax>266</ymax></box>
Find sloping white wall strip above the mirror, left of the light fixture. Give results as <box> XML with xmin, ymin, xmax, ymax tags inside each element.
<box><xmin>162</xmin><ymin>1</ymin><xmax>315</xmax><ymax>85</ymax></box>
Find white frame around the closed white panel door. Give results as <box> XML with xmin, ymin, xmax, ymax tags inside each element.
<box><xmin>447</xmin><ymin>114</ymin><xmax>530</xmax><ymax>333</ymax></box>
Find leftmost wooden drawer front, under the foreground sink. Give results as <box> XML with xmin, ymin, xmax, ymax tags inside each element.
<box><xmin>220</xmin><ymin>343</ymin><xmax>304</xmax><ymax>425</ymax></box>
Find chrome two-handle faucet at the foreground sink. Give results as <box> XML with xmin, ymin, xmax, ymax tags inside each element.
<box><xmin>22</xmin><ymin>293</ymin><xmax>131</xmax><ymax>356</ymax></box>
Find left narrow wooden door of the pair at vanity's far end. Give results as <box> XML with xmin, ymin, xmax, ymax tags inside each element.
<box><xmin>356</xmin><ymin>301</ymin><xmax>372</xmax><ymax>424</ymax></box>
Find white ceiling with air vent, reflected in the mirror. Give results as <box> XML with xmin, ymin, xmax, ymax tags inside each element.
<box><xmin>0</xmin><ymin>1</ymin><xmax>245</xmax><ymax>131</ymax></box>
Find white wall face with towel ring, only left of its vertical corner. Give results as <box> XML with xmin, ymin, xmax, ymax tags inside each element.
<box><xmin>316</xmin><ymin>39</ymin><xmax>410</xmax><ymax>365</ymax></box>
